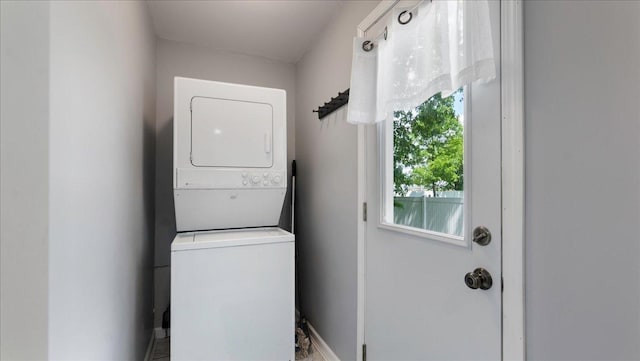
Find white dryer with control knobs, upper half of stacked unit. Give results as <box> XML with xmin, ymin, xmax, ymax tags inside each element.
<box><xmin>173</xmin><ymin>77</ymin><xmax>287</xmax><ymax>232</ymax></box>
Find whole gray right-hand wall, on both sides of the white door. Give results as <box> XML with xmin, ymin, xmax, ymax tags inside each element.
<box><xmin>296</xmin><ymin>1</ymin><xmax>640</xmax><ymax>360</ymax></box>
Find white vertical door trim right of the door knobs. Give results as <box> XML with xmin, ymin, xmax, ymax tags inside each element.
<box><xmin>500</xmin><ymin>0</ymin><xmax>526</xmax><ymax>360</ymax></box>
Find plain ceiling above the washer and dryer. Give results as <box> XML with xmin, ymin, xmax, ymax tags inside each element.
<box><xmin>147</xmin><ymin>0</ymin><xmax>342</xmax><ymax>63</ymax></box>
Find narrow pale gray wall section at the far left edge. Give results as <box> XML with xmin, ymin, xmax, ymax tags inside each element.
<box><xmin>0</xmin><ymin>1</ymin><xmax>49</xmax><ymax>360</ymax></box>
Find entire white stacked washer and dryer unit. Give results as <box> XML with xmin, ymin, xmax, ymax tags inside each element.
<box><xmin>171</xmin><ymin>78</ymin><xmax>295</xmax><ymax>361</ymax></box>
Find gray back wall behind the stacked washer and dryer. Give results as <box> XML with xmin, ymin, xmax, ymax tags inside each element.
<box><xmin>155</xmin><ymin>39</ymin><xmax>296</xmax><ymax>327</ymax></box>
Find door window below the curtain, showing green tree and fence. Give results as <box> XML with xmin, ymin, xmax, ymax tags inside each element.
<box><xmin>381</xmin><ymin>88</ymin><xmax>465</xmax><ymax>240</ymax></box>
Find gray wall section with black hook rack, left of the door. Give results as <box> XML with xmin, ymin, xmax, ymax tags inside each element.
<box><xmin>296</xmin><ymin>1</ymin><xmax>378</xmax><ymax>360</ymax></box>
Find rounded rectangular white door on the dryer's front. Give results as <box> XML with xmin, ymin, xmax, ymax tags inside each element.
<box><xmin>191</xmin><ymin>97</ymin><xmax>273</xmax><ymax>168</ymax></box>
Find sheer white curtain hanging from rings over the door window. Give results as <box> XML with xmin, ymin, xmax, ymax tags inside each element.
<box><xmin>347</xmin><ymin>0</ymin><xmax>496</xmax><ymax>124</ymax></box>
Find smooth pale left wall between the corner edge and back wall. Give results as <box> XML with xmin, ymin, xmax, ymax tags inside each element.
<box><xmin>48</xmin><ymin>1</ymin><xmax>155</xmax><ymax>360</ymax></box>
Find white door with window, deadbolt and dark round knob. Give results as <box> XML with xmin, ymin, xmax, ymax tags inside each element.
<box><xmin>364</xmin><ymin>2</ymin><xmax>502</xmax><ymax>360</ymax></box>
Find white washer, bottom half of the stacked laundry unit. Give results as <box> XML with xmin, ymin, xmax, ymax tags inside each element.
<box><xmin>171</xmin><ymin>228</ymin><xmax>295</xmax><ymax>361</ymax></box>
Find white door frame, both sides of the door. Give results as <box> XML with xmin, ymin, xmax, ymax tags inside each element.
<box><xmin>356</xmin><ymin>0</ymin><xmax>526</xmax><ymax>360</ymax></box>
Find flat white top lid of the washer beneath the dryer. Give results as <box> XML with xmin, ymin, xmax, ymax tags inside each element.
<box><xmin>171</xmin><ymin>227</ymin><xmax>295</xmax><ymax>251</ymax></box>
